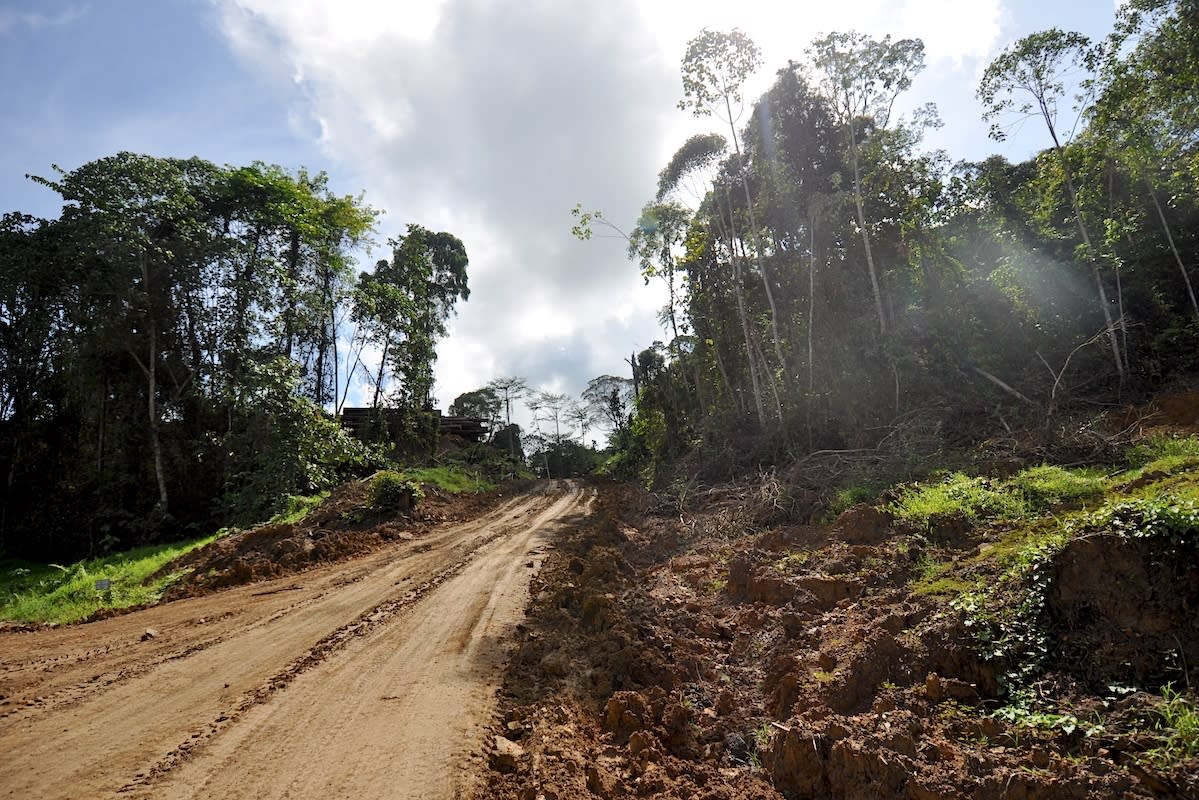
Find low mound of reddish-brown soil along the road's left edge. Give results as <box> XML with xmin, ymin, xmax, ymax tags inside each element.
<box><xmin>162</xmin><ymin>481</ymin><xmax>494</xmax><ymax>600</ymax></box>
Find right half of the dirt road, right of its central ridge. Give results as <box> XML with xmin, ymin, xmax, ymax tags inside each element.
<box><xmin>136</xmin><ymin>491</ymin><xmax>590</xmax><ymax>800</ymax></box>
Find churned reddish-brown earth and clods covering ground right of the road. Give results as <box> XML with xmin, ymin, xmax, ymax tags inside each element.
<box><xmin>481</xmin><ymin>474</ymin><xmax>1199</xmax><ymax>800</ymax></box>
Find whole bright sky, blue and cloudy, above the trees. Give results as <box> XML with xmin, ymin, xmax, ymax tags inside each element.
<box><xmin>0</xmin><ymin>0</ymin><xmax>1115</xmax><ymax>429</ymax></box>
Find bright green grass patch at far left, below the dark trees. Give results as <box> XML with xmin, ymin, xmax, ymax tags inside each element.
<box><xmin>0</xmin><ymin>530</ymin><xmax>227</xmax><ymax>622</ymax></box>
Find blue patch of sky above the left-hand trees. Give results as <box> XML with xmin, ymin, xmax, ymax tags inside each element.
<box><xmin>0</xmin><ymin>0</ymin><xmax>319</xmax><ymax>216</ymax></box>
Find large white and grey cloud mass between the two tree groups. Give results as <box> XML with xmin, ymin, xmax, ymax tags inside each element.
<box><xmin>213</xmin><ymin>0</ymin><xmax>1002</xmax><ymax>405</ymax></box>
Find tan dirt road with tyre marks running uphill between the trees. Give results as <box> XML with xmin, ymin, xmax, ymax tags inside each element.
<box><xmin>0</xmin><ymin>483</ymin><xmax>591</xmax><ymax>799</ymax></box>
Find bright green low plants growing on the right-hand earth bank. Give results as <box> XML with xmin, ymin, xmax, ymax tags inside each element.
<box><xmin>872</xmin><ymin>435</ymin><xmax>1199</xmax><ymax>771</ymax></box>
